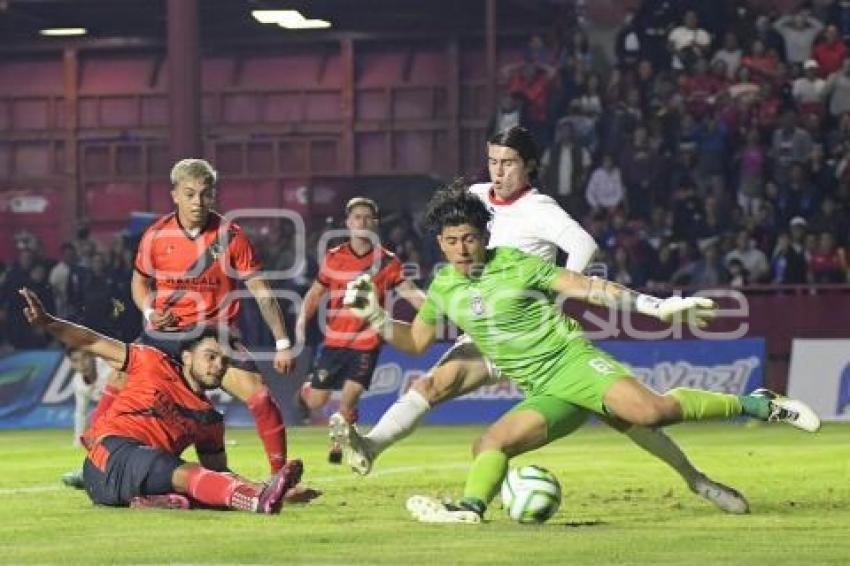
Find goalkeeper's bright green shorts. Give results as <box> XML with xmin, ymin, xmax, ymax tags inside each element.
<box><xmin>511</xmin><ymin>340</ymin><xmax>631</xmax><ymax>441</ymax></box>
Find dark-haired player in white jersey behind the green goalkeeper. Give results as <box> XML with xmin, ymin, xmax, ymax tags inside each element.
<box><xmin>340</xmin><ymin>127</ymin><xmax>749</xmax><ymax>513</ymax></box>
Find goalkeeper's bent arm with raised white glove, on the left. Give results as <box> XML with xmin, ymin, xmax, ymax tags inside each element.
<box><xmin>342</xmin><ymin>275</ymin><xmax>437</xmax><ymax>355</ymax></box>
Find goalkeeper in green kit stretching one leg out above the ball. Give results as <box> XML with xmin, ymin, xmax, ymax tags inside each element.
<box><xmin>344</xmin><ymin>187</ymin><xmax>820</xmax><ymax>522</ymax></box>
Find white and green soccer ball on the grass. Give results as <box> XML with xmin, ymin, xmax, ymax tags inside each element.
<box><xmin>502</xmin><ymin>466</ymin><xmax>561</xmax><ymax>523</ymax></box>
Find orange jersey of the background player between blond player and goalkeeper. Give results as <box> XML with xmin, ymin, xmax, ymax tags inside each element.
<box><xmin>318</xmin><ymin>243</ymin><xmax>404</xmax><ymax>351</ymax></box>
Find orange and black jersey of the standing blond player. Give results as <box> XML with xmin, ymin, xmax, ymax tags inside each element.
<box><xmin>135</xmin><ymin>212</ymin><xmax>261</xmax><ymax>329</ymax></box>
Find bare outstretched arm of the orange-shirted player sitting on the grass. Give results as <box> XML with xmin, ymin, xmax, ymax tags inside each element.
<box><xmin>19</xmin><ymin>288</ymin><xmax>127</xmax><ymax>369</ymax></box>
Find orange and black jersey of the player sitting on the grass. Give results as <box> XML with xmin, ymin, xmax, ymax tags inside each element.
<box><xmin>83</xmin><ymin>344</ymin><xmax>224</xmax><ymax>462</ymax></box>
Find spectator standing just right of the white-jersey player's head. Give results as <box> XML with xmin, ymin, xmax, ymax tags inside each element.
<box><xmin>540</xmin><ymin>120</ymin><xmax>592</xmax><ymax>216</ymax></box>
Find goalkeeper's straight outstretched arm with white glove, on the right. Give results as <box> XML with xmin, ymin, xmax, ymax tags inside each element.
<box><xmin>552</xmin><ymin>269</ymin><xmax>717</xmax><ymax>328</ymax></box>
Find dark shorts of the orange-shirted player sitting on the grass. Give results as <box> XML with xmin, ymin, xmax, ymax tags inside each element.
<box><xmin>83</xmin><ymin>436</ymin><xmax>184</xmax><ymax>506</ymax></box>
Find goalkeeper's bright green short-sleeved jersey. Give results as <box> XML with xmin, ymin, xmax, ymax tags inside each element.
<box><xmin>417</xmin><ymin>248</ymin><xmax>586</xmax><ymax>393</ymax></box>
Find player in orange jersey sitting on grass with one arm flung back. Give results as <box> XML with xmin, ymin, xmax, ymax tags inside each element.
<box><xmin>20</xmin><ymin>289</ymin><xmax>303</xmax><ymax>513</ymax></box>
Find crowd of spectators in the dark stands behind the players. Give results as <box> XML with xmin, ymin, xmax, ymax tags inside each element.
<box><xmin>0</xmin><ymin>0</ymin><xmax>850</xmax><ymax>356</ymax></box>
